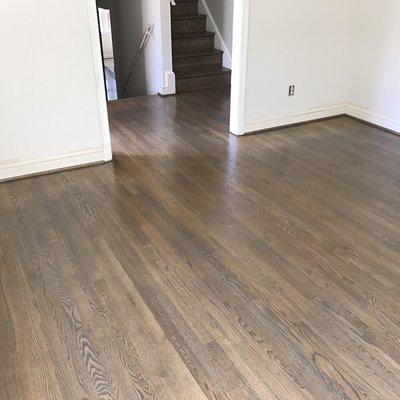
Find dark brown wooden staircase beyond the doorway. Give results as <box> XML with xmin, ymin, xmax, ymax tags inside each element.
<box><xmin>171</xmin><ymin>0</ymin><xmax>231</xmax><ymax>93</ymax></box>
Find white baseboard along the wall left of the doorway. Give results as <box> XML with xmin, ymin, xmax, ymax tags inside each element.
<box><xmin>0</xmin><ymin>147</ymin><xmax>111</xmax><ymax>181</ymax></box>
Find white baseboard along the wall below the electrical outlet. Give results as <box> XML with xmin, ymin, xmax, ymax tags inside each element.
<box><xmin>245</xmin><ymin>104</ymin><xmax>346</xmax><ymax>133</ymax></box>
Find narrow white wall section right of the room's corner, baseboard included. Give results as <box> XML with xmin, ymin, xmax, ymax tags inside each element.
<box><xmin>347</xmin><ymin>0</ymin><xmax>400</xmax><ymax>132</ymax></box>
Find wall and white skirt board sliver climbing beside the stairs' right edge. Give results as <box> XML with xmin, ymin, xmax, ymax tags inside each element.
<box><xmin>199</xmin><ymin>0</ymin><xmax>234</xmax><ymax>68</ymax></box>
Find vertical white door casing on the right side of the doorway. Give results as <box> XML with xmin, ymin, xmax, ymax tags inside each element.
<box><xmin>229</xmin><ymin>0</ymin><xmax>250</xmax><ymax>136</ymax></box>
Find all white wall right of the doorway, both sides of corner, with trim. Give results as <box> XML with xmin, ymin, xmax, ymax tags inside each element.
<box><xmin>231</xmin><ymin>0</ymin><xmax>400</xmax><ymax>134</ymax></box>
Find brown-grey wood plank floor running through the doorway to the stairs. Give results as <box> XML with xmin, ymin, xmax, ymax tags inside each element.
<box><xmin>0</xmin><ymin>89</ymin><xmax>400</xmax><ymax>400</ymax></box>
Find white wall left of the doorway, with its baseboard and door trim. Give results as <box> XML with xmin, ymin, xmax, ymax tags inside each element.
<box><xmin>0</xmin><ymin>0</ymin><xmax>111</xmax><ymax>179</ymax></box>
